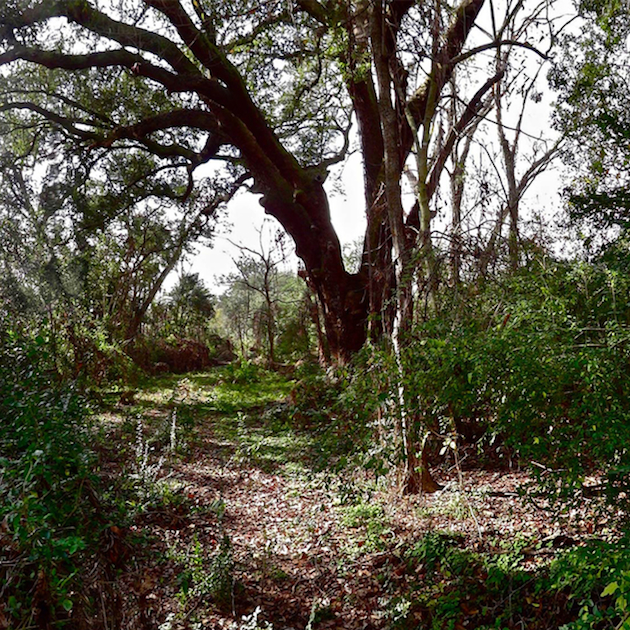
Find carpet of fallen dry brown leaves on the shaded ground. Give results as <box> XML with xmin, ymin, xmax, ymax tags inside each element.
<box><xmin>89</xmin><ymin>380</ymin><xmax>624</xmax><ymax>630</ymax></box>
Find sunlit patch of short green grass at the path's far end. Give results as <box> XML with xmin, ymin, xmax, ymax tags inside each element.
<box><xmin>102</xmin><ymin>366</ymin><xmax>330</xmax><ymax>476</ymax></box>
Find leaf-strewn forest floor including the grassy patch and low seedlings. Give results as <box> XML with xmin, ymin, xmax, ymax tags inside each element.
<box><xmin>98</xmin><ymin>371</ymin><xmax>614</xmax><ymax>630</ymax></box>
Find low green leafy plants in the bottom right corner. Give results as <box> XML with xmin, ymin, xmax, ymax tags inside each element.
<box><xmin>392</xmin><ymin>532</ymin><xmax>630</xmax><ymax>630</ymax></box>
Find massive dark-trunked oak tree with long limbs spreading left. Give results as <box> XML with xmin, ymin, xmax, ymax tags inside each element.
<box><xmin>0</xmin><ymin>0</ymin><xmax>514</xmax><ymax>360</ymax></box>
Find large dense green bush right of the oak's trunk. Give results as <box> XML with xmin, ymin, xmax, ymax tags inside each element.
<box><xmin>345</xmin><ymin>259</ymin><xmax>630</xmax><ymax>510</ymax></box>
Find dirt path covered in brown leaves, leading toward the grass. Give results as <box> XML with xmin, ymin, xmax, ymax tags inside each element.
<box><xmin>102</xmin><ymin>376</ymin><xmax>602</xmax><ymax>630</ymax></box>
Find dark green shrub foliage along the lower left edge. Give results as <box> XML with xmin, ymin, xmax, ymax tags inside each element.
<box><xmin>0</xmin><ymin>329</ymin><xmax>106</xmax><ymax>628</ymax></box>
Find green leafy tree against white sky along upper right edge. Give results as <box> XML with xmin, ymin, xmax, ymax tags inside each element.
<box><xmin>551</xmin><ymin>0</ymin><xmax>630</xmax><ymax>244</ymax></box>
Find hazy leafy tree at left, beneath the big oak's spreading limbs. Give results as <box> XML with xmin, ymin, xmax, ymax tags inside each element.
<box><xmin>0</xmin><ymin>134</ymin><xmax>241</xmax><ymax>348</ymax></box>
